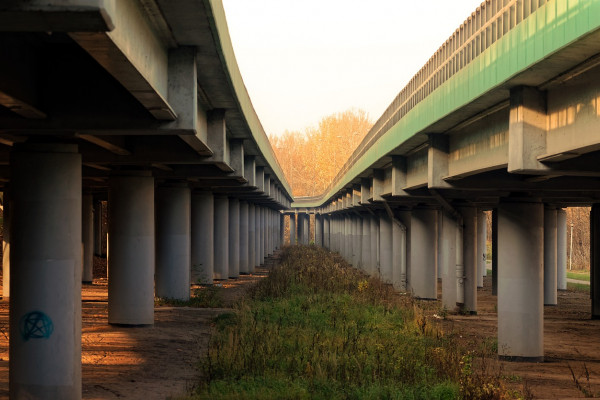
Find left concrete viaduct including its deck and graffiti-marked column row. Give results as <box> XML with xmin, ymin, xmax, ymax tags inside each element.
<box><xmin>0</xmin><ymin>0</ymin><xmax>292</xmax><ymax>399</ymax></box>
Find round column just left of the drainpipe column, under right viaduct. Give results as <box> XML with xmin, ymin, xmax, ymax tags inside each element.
<box><xmin>410</xmin><ymin>208</ymin><xmax>437</xmax><ymax>299</ymax></box>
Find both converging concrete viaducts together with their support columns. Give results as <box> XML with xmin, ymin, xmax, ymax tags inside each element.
<box><xmin>0</xmin><ymin>0</ymin><xmax>600</xmax><ymax>399</ymax></box>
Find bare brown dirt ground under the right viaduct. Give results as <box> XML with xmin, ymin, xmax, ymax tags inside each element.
<box><xmin>439</xmin><ymin>277</ymin><xmax>600</xmax><ymax>399</ymax></box>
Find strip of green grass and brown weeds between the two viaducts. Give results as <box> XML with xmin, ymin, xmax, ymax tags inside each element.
<box><xmin>179</xmin><ymin>246</ymin><xmax>518</xmax><ymax>399</ymax></box>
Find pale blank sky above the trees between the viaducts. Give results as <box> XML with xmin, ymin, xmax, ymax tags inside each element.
<box><xmin>223</xmin><ymin>0</ymin><xmax>481</xmax><ymax>135</ymax></box>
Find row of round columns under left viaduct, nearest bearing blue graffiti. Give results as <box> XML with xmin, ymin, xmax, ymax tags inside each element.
<box><xmin>3</xmin><ymin>144</ymin><xmax>282</xmax><ymax>399</ymax></box>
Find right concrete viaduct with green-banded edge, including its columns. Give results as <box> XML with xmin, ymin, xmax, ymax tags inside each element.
<box><xmin>288</xmin><ymin>0</ymin><xmax>600</xmax><ymax>361</ymax></box>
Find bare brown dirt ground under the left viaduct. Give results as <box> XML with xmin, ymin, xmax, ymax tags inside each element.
<box><xmin>0</xmin><ymin>258</ymin><xmax>268</xmax><ymax>400</ymax></box>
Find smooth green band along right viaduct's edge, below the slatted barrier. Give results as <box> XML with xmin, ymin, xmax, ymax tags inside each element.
<box><xmin>292</xmin><ymin>0</ymin><xmax>600</xmax><ymax>208</ymax></box>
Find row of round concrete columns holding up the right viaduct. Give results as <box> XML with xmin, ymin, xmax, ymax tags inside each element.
<box><xmin>292</xmin><ymin>199</ymin><xmax>572</xmax><ymax>361</ymax></box>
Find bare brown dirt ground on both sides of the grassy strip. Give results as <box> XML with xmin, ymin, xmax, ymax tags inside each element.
<box><xmin>0</xmin><ymin>253</ymin><xmax>600</xmax><ymax>400</ymax></box>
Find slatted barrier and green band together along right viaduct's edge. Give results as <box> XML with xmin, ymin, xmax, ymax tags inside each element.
<box><xmin>297</xmin><ymin>0</ymin><xmax>600</xmax><ymax>207</ymax></box>
